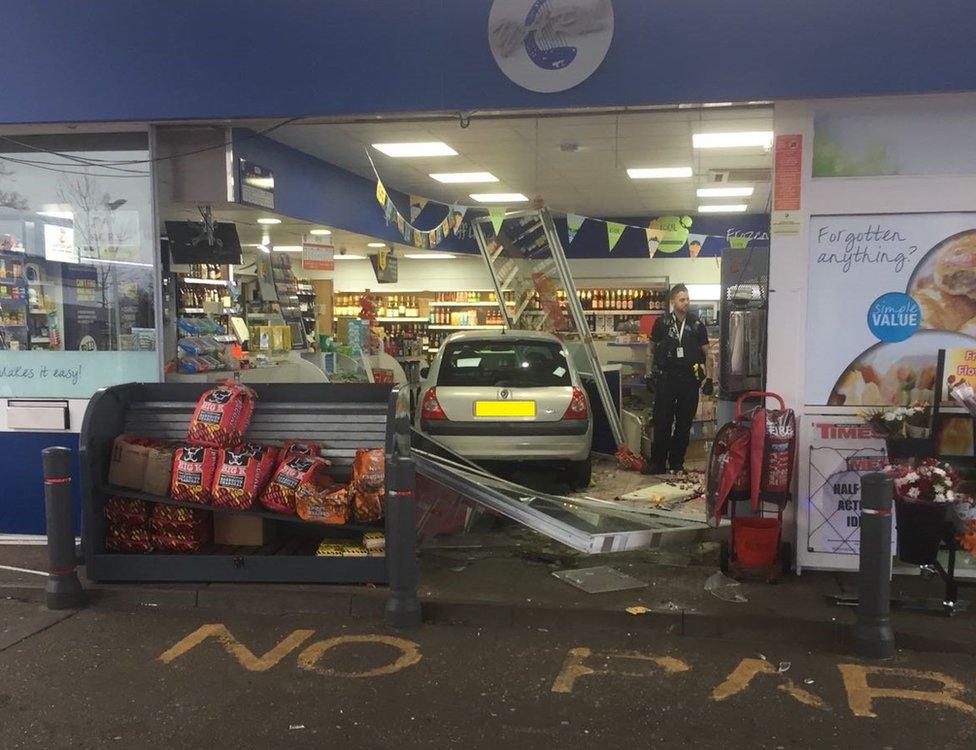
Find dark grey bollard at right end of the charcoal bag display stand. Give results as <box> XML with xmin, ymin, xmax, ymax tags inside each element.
<box><xmin>386</xmin><ymin>455</ymin><xmax>422</xmax><ymax>629</ymax></box>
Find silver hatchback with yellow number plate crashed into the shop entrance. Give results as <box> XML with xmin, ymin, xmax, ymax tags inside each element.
<box><xmin>416</xmin><ymin>331</ymin><xmax>593</xmax><ymax>487</ymax></box>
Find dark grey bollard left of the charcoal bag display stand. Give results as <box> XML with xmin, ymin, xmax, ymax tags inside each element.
<box><xmin>41</xmin><ymin>448</ymin><xmax>85</xmax><ymax>609</ymax></box>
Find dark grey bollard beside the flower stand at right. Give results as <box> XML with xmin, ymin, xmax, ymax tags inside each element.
<box><xmin>854</xmin><ymin>474</ymin><xmax>895</xmax><ymax>659</ymax></box>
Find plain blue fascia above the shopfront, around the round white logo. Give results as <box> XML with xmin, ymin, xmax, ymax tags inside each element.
<box><xmin>0</xmin><ymin>0</ymin><xmax>976</xmax><ymax>122</ymax></box>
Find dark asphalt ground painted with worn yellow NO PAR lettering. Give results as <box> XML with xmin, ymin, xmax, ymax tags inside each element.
<box><xmin>0</xmin><ymin>599</ymin><xmax>976</xmax><ymax>750</ymax></box>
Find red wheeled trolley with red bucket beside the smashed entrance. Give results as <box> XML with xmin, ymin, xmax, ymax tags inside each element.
<box><xmin>706</xmin><ymin>391</ymin><xmax>796</xmax><ymax>583</ymax></box>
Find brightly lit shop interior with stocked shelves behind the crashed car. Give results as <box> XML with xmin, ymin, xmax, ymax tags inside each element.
<box><xmin>157</xmin><ymin>105</ymin><xmax>772</xmax><ymax>472</ymax></box>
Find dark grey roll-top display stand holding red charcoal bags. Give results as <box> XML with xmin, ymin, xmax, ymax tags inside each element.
<box><xmin>80</xmin><ymin>383</ymin><xmax>416</xmax><ymax>585</ymax></box>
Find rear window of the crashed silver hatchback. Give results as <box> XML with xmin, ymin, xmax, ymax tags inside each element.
<box><xmin>437</xmin><ymin>339</ymin><xmax>573</xmax><ymax>388</ymax></box>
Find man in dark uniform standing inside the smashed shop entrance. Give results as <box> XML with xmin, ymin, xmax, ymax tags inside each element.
<box><xmin>647</xmin><ymin>284</ymin><xmax>708</xmax><ymax>474</ymax></box>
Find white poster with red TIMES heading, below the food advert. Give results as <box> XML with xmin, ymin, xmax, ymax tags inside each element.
<box><xmin>797</xmin><ymin>416</ymin><xmax>895</xmax><ymax>570</ymax></box>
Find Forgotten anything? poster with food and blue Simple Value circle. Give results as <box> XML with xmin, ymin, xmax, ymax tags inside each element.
<box><xmin>805</xmin><ymin>213</ymin><xmax>976</xmax><ymax>407</ymax></box>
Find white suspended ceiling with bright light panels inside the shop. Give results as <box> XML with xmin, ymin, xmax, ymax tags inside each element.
<box><xmin>271</xmin><ymin>106</ymin><xmax>773</xmax><ymax>216</ymax></box>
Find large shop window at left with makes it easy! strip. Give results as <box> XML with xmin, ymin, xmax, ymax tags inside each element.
<box><xmin>0</xmin><ymin>133</ymin><xmax>159</xmax><ymax>398</ymax></box>
